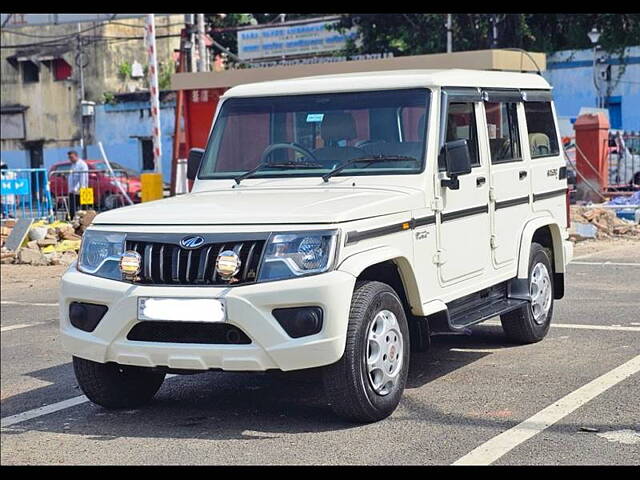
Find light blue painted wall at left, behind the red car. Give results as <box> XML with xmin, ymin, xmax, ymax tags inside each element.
<box><xmin>0</xmin><ymin>102</ymin><xmax>175</xmax><ymax>183</ymax></box>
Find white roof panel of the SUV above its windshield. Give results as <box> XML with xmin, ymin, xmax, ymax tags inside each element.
<box><xmin>224</xmin><ymin>69</ymin><xmax>551</xmax><ymax>98</ymax></box>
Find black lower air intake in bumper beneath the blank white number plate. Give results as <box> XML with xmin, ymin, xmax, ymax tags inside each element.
<box><xmin>127</xmin><ymin>321</ymin><xmax>251</xmax><ymax>345</ymax></box>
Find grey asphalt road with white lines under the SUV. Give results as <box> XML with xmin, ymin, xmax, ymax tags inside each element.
<box><xmin>0</xmin><ymin>244</ymin><xmax>640</xmax><ymax>465</ymax></box>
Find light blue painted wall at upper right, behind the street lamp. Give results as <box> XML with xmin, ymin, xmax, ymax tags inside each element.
<box><xmin>544</xmin><ymin>46</ymin><xmax>640</xmax><ymax>131</ymax></box>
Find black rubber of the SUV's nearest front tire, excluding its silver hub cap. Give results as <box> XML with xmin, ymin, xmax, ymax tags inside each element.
<box><xmin>323</xmin><ymin>281</ymin><xmax>410</xmax><ymax>422</ymax></box>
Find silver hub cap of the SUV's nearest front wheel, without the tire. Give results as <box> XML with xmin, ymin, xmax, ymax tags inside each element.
<box><xmin>366</xmin><ymin>310</ymin><xmax>403</xmax><ymax>395</ymax></box>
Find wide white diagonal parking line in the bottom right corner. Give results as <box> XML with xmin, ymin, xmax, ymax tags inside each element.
<box><xmin>453</xmin><ymin>355</ymin><xmax>640</xmax><ymax>465</ymax></box>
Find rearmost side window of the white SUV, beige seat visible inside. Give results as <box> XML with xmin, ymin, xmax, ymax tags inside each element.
<box><xmin>524</xmin><ymin>102</ymin><xmax>560</xmax><ymax>158</ymax></box>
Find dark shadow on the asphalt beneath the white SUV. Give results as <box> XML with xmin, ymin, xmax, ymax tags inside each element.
<box><xmin>2</xmin><ymin>327</ymin><xmax>528</xmax><ymax>440</ymax></box>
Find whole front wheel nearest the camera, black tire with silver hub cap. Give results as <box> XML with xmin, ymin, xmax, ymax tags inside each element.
<box><xmin>323</xmin><ymin>281</ymin><xmax>409</xmax><ymax>422</ymax></box>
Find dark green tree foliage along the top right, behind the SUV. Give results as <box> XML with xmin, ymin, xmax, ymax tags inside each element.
<box><xmin>338</xmin><ymin>13</ymin><xmax>640</xmax><ymax>56</ymax></box>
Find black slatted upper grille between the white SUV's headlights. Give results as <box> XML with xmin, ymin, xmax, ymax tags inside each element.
<box><xmin>126</xmin><ymin>239</ymin><xmax>265</xmax><ymax>286</ymax></box>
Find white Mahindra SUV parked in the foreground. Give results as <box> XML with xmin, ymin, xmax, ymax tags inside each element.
<box><xmin>60</xmin><ymin>70</ymin><xmax>572</xmax><ymax>422</ymax></box>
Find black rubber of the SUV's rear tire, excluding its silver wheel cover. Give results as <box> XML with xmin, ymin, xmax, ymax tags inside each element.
<box><xmin>500</xmin><ymin>242</ymin><xmax>553</xmax><ymax>344</ymax></box>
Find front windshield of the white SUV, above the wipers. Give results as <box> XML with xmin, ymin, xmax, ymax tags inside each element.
<box><xmin>198</xmin><ymin>88</ymin><xmax>429</xmax><ymax>179</ymax></box>
